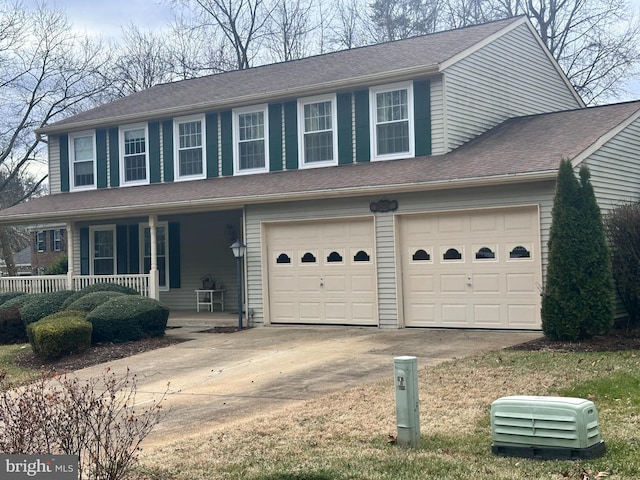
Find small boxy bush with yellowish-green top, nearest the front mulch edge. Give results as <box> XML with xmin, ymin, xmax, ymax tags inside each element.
<box><xmin>27</xmin><ymin>314</ymin><xmax>93</xmax><ymax>360</ymax></box>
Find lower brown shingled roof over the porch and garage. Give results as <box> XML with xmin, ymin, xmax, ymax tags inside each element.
<box><xmin>6</xmin><ymin>101</ymin><xmax>640</xmax><ymax>224</ymax></box>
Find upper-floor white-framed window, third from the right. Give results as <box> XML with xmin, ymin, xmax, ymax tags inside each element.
<box><xmin>233</xmin><ymin>105</ymin><xmax>269</xmax><ymax>174</ymax></box>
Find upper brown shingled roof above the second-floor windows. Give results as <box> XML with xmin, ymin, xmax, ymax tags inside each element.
<box><xmin>38</xmin><ymin>16</ymin><xmax>527</xmax><ymax>133</ymax></box>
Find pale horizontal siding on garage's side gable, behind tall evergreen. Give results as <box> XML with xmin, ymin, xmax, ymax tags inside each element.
<box><xmin>576</xmin><ymin>119</ymin><xmax>640</xmax><ymax>212</ymax></box>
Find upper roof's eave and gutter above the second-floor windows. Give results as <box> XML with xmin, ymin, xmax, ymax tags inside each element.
<box><xmin>35</xmin><ymin>64</ymin><xmax>440</xmax><ymax>135</ymax></box>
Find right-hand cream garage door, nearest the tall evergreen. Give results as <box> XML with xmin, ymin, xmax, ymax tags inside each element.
<box><xmin>399</xmin><ymin>207</ymin><xmax>542</xmax><ymax>329</ymax></box>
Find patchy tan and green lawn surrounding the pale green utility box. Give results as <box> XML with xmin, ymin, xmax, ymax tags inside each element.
<box><xmin>137</xmin><ymin>351</ymin><xmax>640</xmax><ymax>480</ymax></box>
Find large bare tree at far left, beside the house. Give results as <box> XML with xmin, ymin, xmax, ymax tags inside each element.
<box><xmin>0</xmin><ymin>2</ymin><xmax>107</xmax><ymax>274</ymax></box>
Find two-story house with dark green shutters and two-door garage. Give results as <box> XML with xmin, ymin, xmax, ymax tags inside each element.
<box><xmin>0</xmin><ymin>17</ymin><xmax>640</xmax><ymax>329</ymax></box>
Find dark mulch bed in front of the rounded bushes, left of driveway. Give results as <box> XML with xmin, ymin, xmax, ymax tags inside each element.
<box><xmin>14</xmin><ymin>337</ymin><xmax>185</xmax><ymax>372</ymax></box>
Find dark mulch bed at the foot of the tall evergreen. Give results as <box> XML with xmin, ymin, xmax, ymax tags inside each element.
<box><xmin>508</xmin><ymin>330</ymin><xmax>640</xmax><ymax>352</ymax></box>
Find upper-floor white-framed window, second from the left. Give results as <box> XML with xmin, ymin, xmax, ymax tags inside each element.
<box><xmin>120</xmin><ymin>125</ymin><xmax>149</xmax><ymax>185</ymax></box>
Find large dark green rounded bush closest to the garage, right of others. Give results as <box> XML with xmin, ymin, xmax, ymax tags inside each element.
<box><xmin>87</xmin><ymin>295</ymin><xmax>169</xmax><ymax>343</ymax></box>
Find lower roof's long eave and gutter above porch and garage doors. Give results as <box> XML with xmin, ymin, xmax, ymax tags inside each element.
<box><xmin>0</xmin><ymin>169</ymin><xmax>557</xmax><ymax>225</ymax></box>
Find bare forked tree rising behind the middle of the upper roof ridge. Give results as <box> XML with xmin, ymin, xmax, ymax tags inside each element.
<box><xmin>172</xmin><ymin>0</ymin><xmax>273</xmax><ymax>70</ymax></box>
